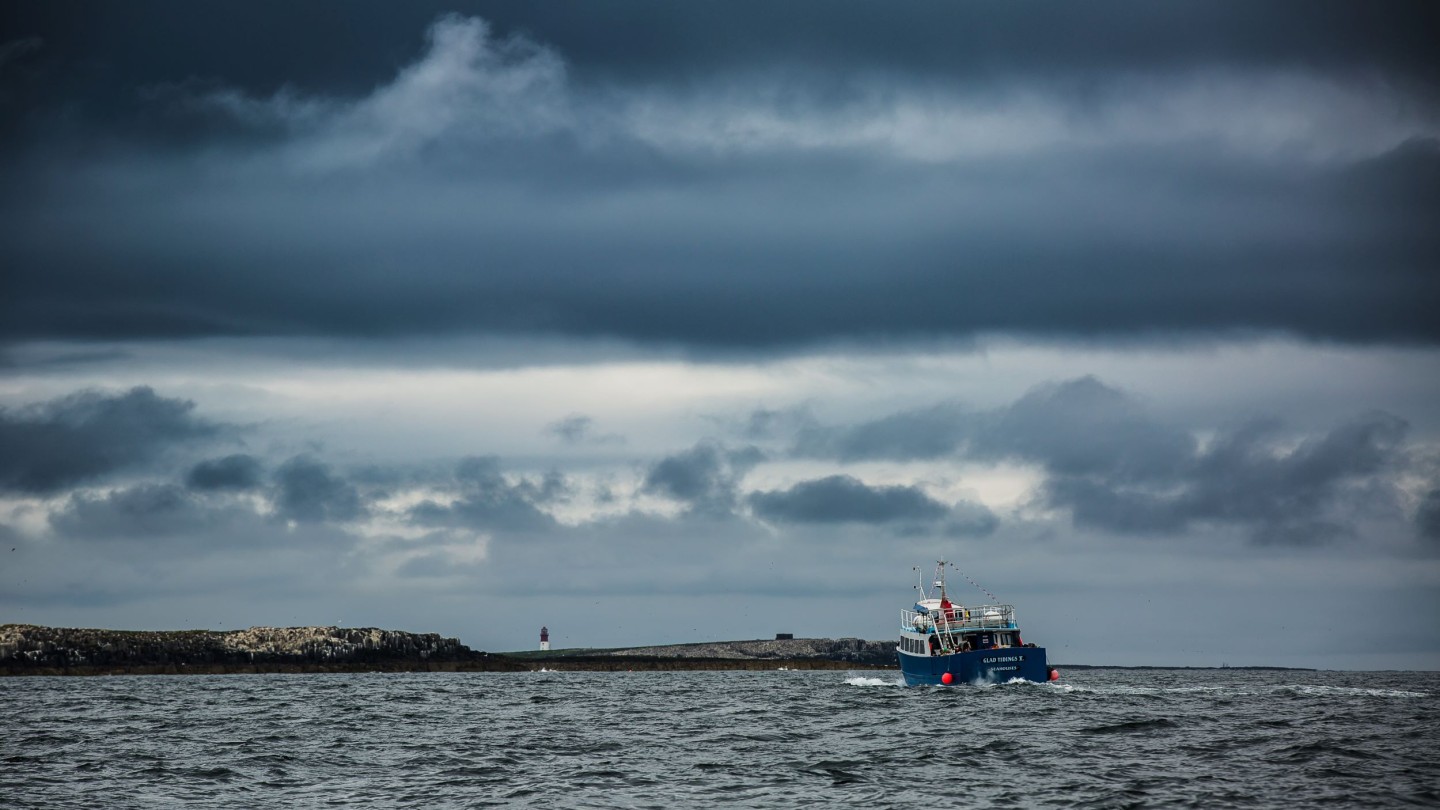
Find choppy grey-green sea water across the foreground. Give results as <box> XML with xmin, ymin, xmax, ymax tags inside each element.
<box><xmin>0</xmin><ymin>670</ymin><xmax>1440</xmax><ymax>809</ymax></box>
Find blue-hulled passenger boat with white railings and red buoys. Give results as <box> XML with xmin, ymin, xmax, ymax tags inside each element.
<box><xmin>896</xmin><ymin>559</ymin><xmax>1060</xmax><ymax>686</ymax></box>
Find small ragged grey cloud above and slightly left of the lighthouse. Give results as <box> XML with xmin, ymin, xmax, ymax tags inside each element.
<box><xmin>409</xmin><ymin>457</ymin><xmax>572</xmax><ymax>532</ymax></box>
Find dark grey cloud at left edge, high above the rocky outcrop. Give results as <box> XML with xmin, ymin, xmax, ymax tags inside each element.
<box><xmin>0</xmin><ymin>388</ymin><xmax>224</xmax><ymax>494</ymax></box>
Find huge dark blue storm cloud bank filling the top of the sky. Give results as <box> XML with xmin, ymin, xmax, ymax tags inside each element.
<box><xmin>0</xmin><ymin>3</ymin><xmax>1440</xmax><ymax>350</ymax></box>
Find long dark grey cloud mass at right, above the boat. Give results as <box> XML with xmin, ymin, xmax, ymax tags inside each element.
<box><xmin>795</xmin><ymin>378</ymin><xmax>1426</xmax><ymax>545</ymax></box>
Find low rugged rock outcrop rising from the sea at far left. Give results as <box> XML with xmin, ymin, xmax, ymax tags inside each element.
<box><xmin>0</xmin><ymin>624</ymin><xmax>518</xmax><ymax>673</ymax></box>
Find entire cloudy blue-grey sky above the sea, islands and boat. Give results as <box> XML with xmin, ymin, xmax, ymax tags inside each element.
<box><xmin>0</xmin><ymin>0</ymin><xmax>1440</xmax><ymax>670</ymax></box>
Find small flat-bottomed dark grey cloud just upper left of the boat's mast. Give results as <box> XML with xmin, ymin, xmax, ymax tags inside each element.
<box><xmin>746</xmin><ymin>476</ymin><xmax>948</xmax><ymax>523</ymax></box>
